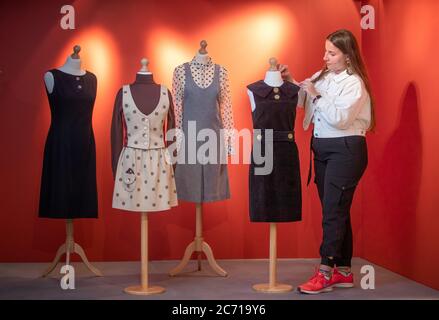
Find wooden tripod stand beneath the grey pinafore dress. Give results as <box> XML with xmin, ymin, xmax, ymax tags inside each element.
<box><xmin>169</xmin><ymin>203</ymin><xmax>227</xmax><ymax>277</ymax></box>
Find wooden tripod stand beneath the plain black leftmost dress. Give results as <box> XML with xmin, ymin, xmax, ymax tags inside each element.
<box><xmin>42</xmin><ymin>219</ymin><xmax>103</xmax><ymax>277</ymax></box>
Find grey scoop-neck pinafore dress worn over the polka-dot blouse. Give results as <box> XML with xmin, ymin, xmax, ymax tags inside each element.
<box><xmin>175</xmin><ymin>63</ymin><xmax>230</xmax><ymax>203</ymax></box>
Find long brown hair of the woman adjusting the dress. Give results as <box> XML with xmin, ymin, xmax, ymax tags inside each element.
<box><xmin>312</xmin><ymin>29</ymin><xmax>376</xmax><ymax>131</ymax></box>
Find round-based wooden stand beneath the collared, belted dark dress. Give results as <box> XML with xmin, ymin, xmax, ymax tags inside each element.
<box><xmin>253</xmin><ymin>223</ymin><xmax>293</xmax><ymax>293</ymax></box>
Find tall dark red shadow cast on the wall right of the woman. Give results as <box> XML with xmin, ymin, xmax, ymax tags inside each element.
<box><xmin>377</xmin><ymin>82</ymin><xmax>422</xmax><ymax>275</ymax></box>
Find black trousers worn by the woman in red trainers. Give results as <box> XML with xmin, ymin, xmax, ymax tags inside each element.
<box><xmin>311</xmin><ymin>136</ymin><xmax>367</xmax><ymax>266</ymax></box>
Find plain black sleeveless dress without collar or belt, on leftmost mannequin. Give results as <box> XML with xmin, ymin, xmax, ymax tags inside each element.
<box><xmin>39</xmin><ymin>69</ymin><xmax>98</xmax><ymax>219</ymax></box>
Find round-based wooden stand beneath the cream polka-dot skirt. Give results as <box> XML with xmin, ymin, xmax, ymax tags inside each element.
<box><xmin>124</xmin><ymin>213</ymin><xmax>165</xmax><ymax>295</ymax></box>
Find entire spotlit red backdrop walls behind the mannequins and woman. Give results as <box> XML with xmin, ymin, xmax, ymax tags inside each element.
<box><xmin>0</xmin><ymin>0</ymin><xmax>439</xmax><ymax>287</ymax></box>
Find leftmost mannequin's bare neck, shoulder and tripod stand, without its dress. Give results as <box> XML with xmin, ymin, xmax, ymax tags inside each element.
<box><xmin>43</xmin><ymin>45</ymin><xmax>103</xmax><ymax>277</ymax></box>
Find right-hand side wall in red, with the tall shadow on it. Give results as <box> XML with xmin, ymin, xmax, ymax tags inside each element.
<box><xmin>361</xmin><ymin>0</ymin><xmax>439</xmax><ymax>289</ymax></box>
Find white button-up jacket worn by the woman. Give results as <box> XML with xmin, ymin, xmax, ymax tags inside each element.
<box><xmin>298</xmin><ymin>70</ymin><xmax>371</xmax><ymax>138</ymax></box>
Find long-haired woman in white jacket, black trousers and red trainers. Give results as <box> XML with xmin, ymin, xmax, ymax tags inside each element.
<box><xmin>279</xmin><ymin>30</ymin><xmax>375</xmax><ymax>294</ymax></box>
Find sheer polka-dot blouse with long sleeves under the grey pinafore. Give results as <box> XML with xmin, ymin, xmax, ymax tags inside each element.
<box><xmin>172</xmin><ymin>57</ymin><xmax>234</xmax><ymax>154</ymax></box>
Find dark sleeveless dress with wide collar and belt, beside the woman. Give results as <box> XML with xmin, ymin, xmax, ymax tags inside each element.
<box><xmin>247</xmin><ymin>80</ymin><xmax>302</xmax><ymax>222</ymax></box>
